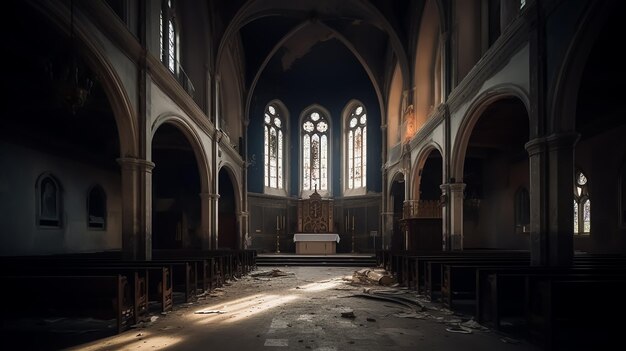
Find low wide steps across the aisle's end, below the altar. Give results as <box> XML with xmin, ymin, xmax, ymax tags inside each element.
<box><xmin>256</xmin><ymin>254</ymin><xmax>376</xmax><ymax>267</ymax></box>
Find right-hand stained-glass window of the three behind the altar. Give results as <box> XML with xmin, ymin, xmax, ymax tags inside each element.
<box><xmin>345</xmin><ymin>104</ymin><xmax>367</xmax><ymax>189</ymax></box>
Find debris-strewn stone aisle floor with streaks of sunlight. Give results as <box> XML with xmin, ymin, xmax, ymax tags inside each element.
<box><xmin>9</xmin><ymin>267</ymin><xmax>537</xmax><ymax>351</ymax></box>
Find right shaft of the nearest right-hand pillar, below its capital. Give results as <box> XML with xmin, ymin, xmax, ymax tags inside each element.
<box><xmin>546</xmin><ymin>133</ymin><xmax>580</xmax><ymax>266</ymax></box>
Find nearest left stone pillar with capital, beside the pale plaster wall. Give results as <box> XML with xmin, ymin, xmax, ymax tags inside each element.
<box><xmin>117</xmin><ymin>157</ymin><xmax>154</xmax><ymax>260</ymax></box>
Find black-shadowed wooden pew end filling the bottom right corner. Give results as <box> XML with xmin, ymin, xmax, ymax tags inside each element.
<box><xmin>526</xmin><ymin>274</ymin><xmax>626</xmax><ymax>350</ymax></box>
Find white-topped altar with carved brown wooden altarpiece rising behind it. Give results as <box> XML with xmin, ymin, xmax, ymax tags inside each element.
<box><xmin>293</xmin><ymin>189</ymin><xmax>340</xmax><ymax>255</ymax></box>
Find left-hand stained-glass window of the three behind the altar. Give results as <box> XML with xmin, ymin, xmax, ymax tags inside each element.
<box><xmin>264</xmin><ymin>104</ymin><xmax>285</xmax><ymax>189</ymax></box>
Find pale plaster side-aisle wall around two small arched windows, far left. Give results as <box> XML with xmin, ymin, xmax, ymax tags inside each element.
<box><xmin>0</xmin><ymin>141</ymin><xmax>122</xmax><ymax>255</ymax></box>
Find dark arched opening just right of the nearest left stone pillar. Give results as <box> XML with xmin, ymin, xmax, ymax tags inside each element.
<box><xmin>152</xmin><ymin>122</ymin><xmax>201</xmax><ymax>250</ymax></box>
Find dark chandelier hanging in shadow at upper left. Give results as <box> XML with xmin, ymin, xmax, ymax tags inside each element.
<box><xmin>47</xmin><ymin>0</ymin><xmax>93</xmax><ymax>115</ymax></box>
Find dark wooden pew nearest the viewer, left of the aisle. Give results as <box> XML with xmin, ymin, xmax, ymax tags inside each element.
<box><xmin>0</xmin><ymin>275</ymin><xmax>135</xmax><ymax>333</ymax></box>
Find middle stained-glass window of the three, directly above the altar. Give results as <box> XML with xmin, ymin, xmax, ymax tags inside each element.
<box><xmin>300</xmin><ymin>110</ymin><xmax>330</xmax><ymax>191</ymax></box>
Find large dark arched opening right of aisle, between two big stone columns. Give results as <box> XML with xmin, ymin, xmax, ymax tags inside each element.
<box><xmin>463</xmin><ymin>97</ymin><xmax>530</xmax><ymax>249</ymax></box>
